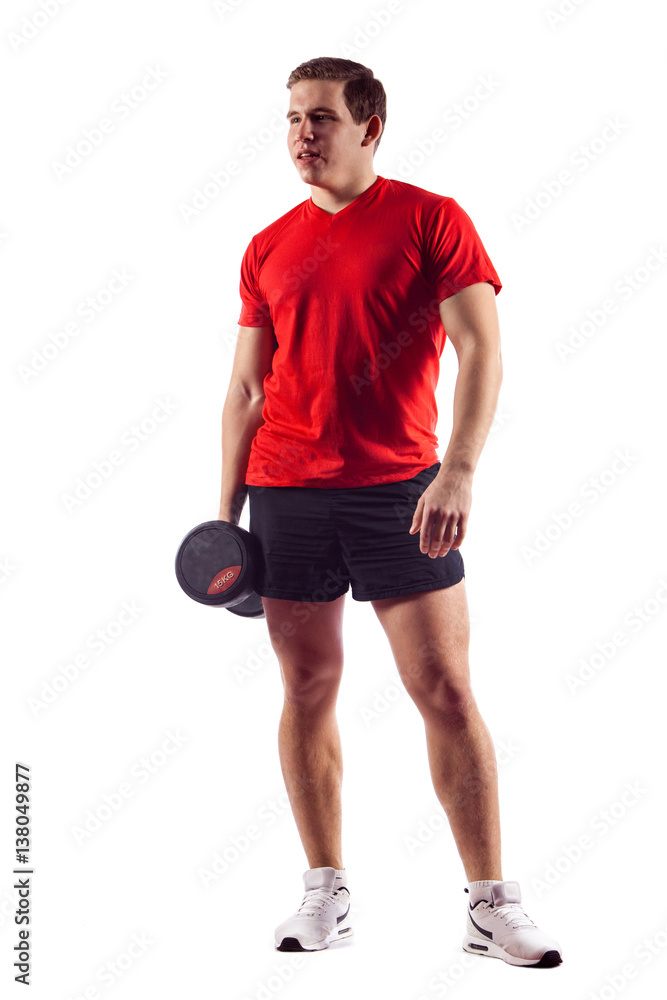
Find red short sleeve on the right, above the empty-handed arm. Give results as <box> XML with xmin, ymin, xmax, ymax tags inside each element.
<box><xmin>423</xmin><ymin>198</ymin><xmax>502</xmax><ymax>302</ymax></box>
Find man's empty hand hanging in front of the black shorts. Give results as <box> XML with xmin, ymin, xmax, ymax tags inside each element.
<box><xmin>410</xmin><ymin>469</ymin><xmax>472</xmax><ymax>559</ymax></box>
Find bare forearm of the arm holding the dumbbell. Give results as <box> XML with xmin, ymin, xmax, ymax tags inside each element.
<box><xmin>219</xmin><ymin>389</ymin><xmax>264</xmax><ymax>524</ymax></box>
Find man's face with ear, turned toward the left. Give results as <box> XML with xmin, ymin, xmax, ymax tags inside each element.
<box><xmin>287</xmin><ymin>80</ymin><xmax>380</xmax><ymax>186</ymax></box>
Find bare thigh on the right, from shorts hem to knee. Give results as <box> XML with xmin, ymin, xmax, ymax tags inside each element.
<box><xmin>372</xmin><ymin>584</ymin><xmax>472</xmax><ymax>708</ymax></box>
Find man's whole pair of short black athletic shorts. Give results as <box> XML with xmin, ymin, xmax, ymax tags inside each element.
<box><xmin>247</xmin><ymin>462</ymin><xmax>465</xmax><ymax>602</ymax></box>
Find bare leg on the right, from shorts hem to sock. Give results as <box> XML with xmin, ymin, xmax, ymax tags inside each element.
<box><xmin>372</xmin><ymin>580</ymin><xmax>502</xmax><ymax>882</ymax></box>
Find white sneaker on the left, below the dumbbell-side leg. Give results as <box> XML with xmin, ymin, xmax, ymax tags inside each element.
<box><xmin>275</xmin><ymin>868</ymin><xmax>352</xmax><ymax>951</ymax></box>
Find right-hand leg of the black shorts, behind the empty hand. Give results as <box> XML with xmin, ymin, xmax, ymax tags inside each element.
<box><xmin>333</xmin><ymin>462</ymin><xmax>465</xmax><ymax>601</ymax></box>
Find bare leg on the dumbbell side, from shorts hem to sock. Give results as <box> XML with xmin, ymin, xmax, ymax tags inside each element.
<box><xmin>262</xmin><ymin>595</ymin><xmax>345</xmax><ymax>869</ymax></box>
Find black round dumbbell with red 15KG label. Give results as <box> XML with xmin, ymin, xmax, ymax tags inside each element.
<box><xmin>176</xmin><ymin>520</ymin><xmax>266</xmax><ymax>618</ymax></box>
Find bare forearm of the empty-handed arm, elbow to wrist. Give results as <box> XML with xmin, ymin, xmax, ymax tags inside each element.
<box><xmin>440</xmin><ymin>345</ymin><xmax>503</xmax><ymax>475</ymax></box>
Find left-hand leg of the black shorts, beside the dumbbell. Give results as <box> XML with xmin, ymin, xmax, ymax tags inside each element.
<box><xmin>248</xmin><ymin>485</ymin><xmax>349</xmax><ymax>602</ymax></box>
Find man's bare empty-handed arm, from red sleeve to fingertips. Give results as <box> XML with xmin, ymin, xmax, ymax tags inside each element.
<box><xmin>410</xmin><ymin>281</ymin><xmax>503</xmax><ymax>558</ymax></box>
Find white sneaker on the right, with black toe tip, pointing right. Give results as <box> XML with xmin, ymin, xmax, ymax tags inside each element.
<box><xmin>463</xmin><ymin>882</ymin><xmax>563</xmax><ymax>968</ymax></box>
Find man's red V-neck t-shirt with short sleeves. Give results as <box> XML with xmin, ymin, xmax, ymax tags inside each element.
<box><xmin>238</xmin><ymin>176</ymin><xmax>502</xmax><ymax>488</ymax></box>
